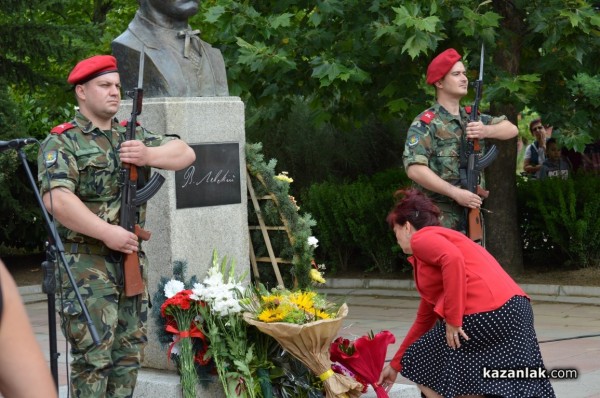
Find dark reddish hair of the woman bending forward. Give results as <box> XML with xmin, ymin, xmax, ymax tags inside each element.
<box><xmin>386</xmin><ymin>188</ymin><xmax>441</xmax><ymax>230</ymax></box>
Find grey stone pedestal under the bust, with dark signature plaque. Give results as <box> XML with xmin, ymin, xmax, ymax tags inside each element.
<box><xmin>117</xmin><ymin>97</ymin><xmax>250</xmax><ymax>396</ymax></box>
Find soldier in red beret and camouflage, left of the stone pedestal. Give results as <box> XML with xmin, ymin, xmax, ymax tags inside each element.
<box><xmin>38</xmin><ymin>55</ymin><xmax>195</xmax><ymax>398</ymax></box>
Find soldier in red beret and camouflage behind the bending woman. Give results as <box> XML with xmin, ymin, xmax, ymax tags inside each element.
<box><xmin>403</xmin><ymin>48</ymin><xmax>518</xmax><ymax>233</ymax></box>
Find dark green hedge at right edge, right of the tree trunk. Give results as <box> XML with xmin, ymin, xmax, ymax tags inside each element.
<box><xmin>519</xmin><ymin>173</ymin><xmax>600</xmax><ymax>268</ymax></box>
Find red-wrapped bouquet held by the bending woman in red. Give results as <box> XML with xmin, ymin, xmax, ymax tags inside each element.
<box><xmin>329</xmin><ymin>330</ymin><xmax>396</xmax><ymax>398</ymax></box>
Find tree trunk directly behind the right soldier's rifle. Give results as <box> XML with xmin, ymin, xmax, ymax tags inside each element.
<box><xmin>484</xmin><ymin>1</ymin><xmax>523</xmax><ymax>275</ymax></box>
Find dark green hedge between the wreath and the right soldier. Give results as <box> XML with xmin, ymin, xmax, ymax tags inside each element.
<box><xmin>307</xmin><ymin>168</ymin><xmax>410</xmax><ymax>272</ymax></box>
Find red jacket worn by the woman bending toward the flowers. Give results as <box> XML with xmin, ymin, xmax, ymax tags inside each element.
<box><xmin>390</xmin><ymin>227</ymin><xmax>528</xmax><ymax>371</ymax></box>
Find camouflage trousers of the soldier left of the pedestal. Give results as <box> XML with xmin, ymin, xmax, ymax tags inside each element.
<box><xmin>58</xmin><ymin>254</ymin><xmax>148</xmax><ymax>398</ymax></box>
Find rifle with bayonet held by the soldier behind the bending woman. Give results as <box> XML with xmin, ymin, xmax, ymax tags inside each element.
<box><xmin>461</xmin><ymin>43</ymin><xmax>498</xmax><ymax>244</ymax></box>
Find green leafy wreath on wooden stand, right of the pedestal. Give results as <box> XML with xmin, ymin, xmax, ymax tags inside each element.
<box><xmin>246</xmin><ymin>143</ymin><xmax>316</xmax><ymax>289</ymax></box>
